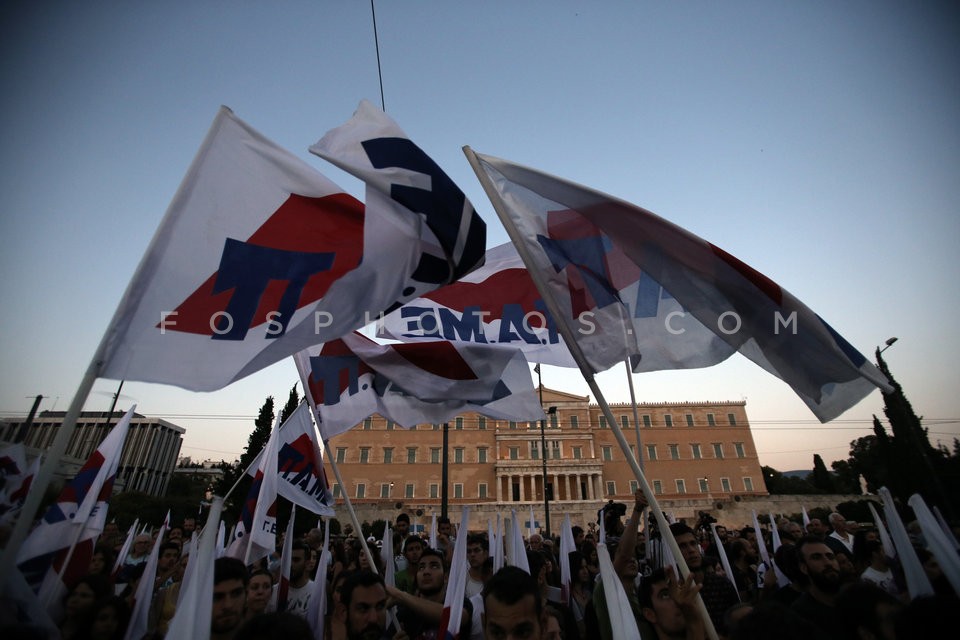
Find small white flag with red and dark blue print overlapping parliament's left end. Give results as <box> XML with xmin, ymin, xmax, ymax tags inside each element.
<box><xmin>247</xmin><ymin>402</ymin><xmax>334</xmax><ymax>517</ymax></box>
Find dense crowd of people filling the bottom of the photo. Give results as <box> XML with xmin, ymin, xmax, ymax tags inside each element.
<box><xmin>5</xmin><ymin>492</ymin><xmax>960</xmax><ymax>640</ymax></box>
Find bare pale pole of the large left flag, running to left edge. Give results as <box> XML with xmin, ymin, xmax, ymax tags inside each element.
<box><xmin>0</xmin><ymin>350</ymin><xmax>106</xmax><ymax>576</ymax></box>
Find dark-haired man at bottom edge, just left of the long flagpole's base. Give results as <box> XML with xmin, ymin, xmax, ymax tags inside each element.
<box><xmin>639</xmin><ymin>567</ymin><xmax>707</xmax><ymax>640</ymax></box>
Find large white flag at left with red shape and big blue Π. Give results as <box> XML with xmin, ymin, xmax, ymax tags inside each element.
<box><xmin>98</xmin><ymin>107</ymin><xmax>485</xmax><ymax>391</ymax></box>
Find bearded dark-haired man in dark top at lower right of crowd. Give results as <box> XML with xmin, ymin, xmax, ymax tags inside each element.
<box><xmin>790</xmin><ymin>537</ymin><xmax>841</xmax><ymax>638</ymax></box>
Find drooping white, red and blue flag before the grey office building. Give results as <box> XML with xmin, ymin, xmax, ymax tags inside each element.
<box><xmin>17</xmin><ymin>406</ymin><xmax>136</xmax><ymax>606</ymax></box>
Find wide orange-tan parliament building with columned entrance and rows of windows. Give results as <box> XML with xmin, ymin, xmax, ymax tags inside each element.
<box><xmin>329</xmin><ymin>388</ymin><xmax>768</xmax><ymax>533</ymax></box>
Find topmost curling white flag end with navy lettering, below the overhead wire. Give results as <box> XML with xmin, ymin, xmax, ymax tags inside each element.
<box><xmin>310</xmin><ymin>100</ymin><xmax>487</xmax><ymax>300</ymax></box>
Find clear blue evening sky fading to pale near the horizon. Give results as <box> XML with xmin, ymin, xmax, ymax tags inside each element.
<box><xmin>0</xmin><ymin>0</ymin><xmax>960</xmax><ymax>470</ymax></box>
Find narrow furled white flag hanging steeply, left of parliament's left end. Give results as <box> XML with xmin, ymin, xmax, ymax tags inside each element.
<box><xmin>224</xmin><ymin>416</ymin><xmax>280</xmax><ymax>564</ymax></box>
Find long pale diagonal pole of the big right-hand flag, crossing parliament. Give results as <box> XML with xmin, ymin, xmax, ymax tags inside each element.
<box><xmin>463</xmin><ymin>146</ymin><xmax>718</xmax><ymax>640</ymax></box>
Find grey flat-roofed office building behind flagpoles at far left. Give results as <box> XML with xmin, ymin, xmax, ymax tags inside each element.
<box><xmin>0</xmin><ymin>411</ymin><xmax>186</xmax><ymax>496</ymax></box>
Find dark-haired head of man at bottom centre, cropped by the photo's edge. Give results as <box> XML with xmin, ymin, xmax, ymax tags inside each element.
<box><xmin>481</xmin><ymin>566</ymin><xmax>547</xmax><ymax>640</ymax></box>
